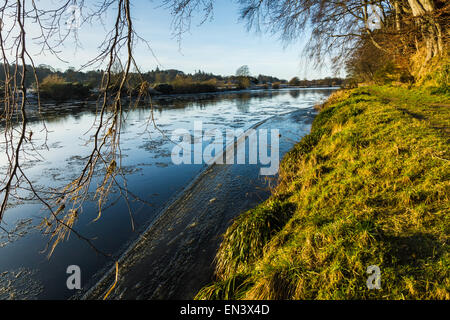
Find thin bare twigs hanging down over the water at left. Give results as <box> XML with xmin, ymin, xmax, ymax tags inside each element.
<box><xmin>0</xmin><ymin>0</ymin><xmax>153</xmax><ymax>254</ymax></box>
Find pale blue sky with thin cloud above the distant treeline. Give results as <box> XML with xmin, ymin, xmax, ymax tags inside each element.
<box><xmin>25</xmin><ymin>0</ymin><xmax>331</xmax><ymax>79</ymax></box>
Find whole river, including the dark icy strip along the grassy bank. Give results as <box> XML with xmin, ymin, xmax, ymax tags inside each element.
<box><xmin>0</xmin><ymin>88</ymin><xmax>334</xmax><ymax>299</ymax></box>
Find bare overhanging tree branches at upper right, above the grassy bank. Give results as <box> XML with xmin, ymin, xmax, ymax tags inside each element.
<box><xmin>165</xmin><ymin>0</ymin><xmax>449</xmax><ymax>68</ymax></box>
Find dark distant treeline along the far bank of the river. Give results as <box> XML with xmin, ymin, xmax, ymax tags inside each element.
<box><xmin>0</xmin><ymin>64</ymin><xmax>344</xmax><ymax>100</ymax></box>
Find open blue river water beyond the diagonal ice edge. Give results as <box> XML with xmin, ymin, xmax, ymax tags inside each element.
<box><xmin>0</xmin><ymin>88</ymin><xmax>334</xmax><ymax>299</ymax></box>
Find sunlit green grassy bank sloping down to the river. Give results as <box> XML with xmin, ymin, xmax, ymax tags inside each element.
<box><xmin>196</xmin><ymin>86</ymin><xmax>450</xmax><ymax>299</ymax></box>
